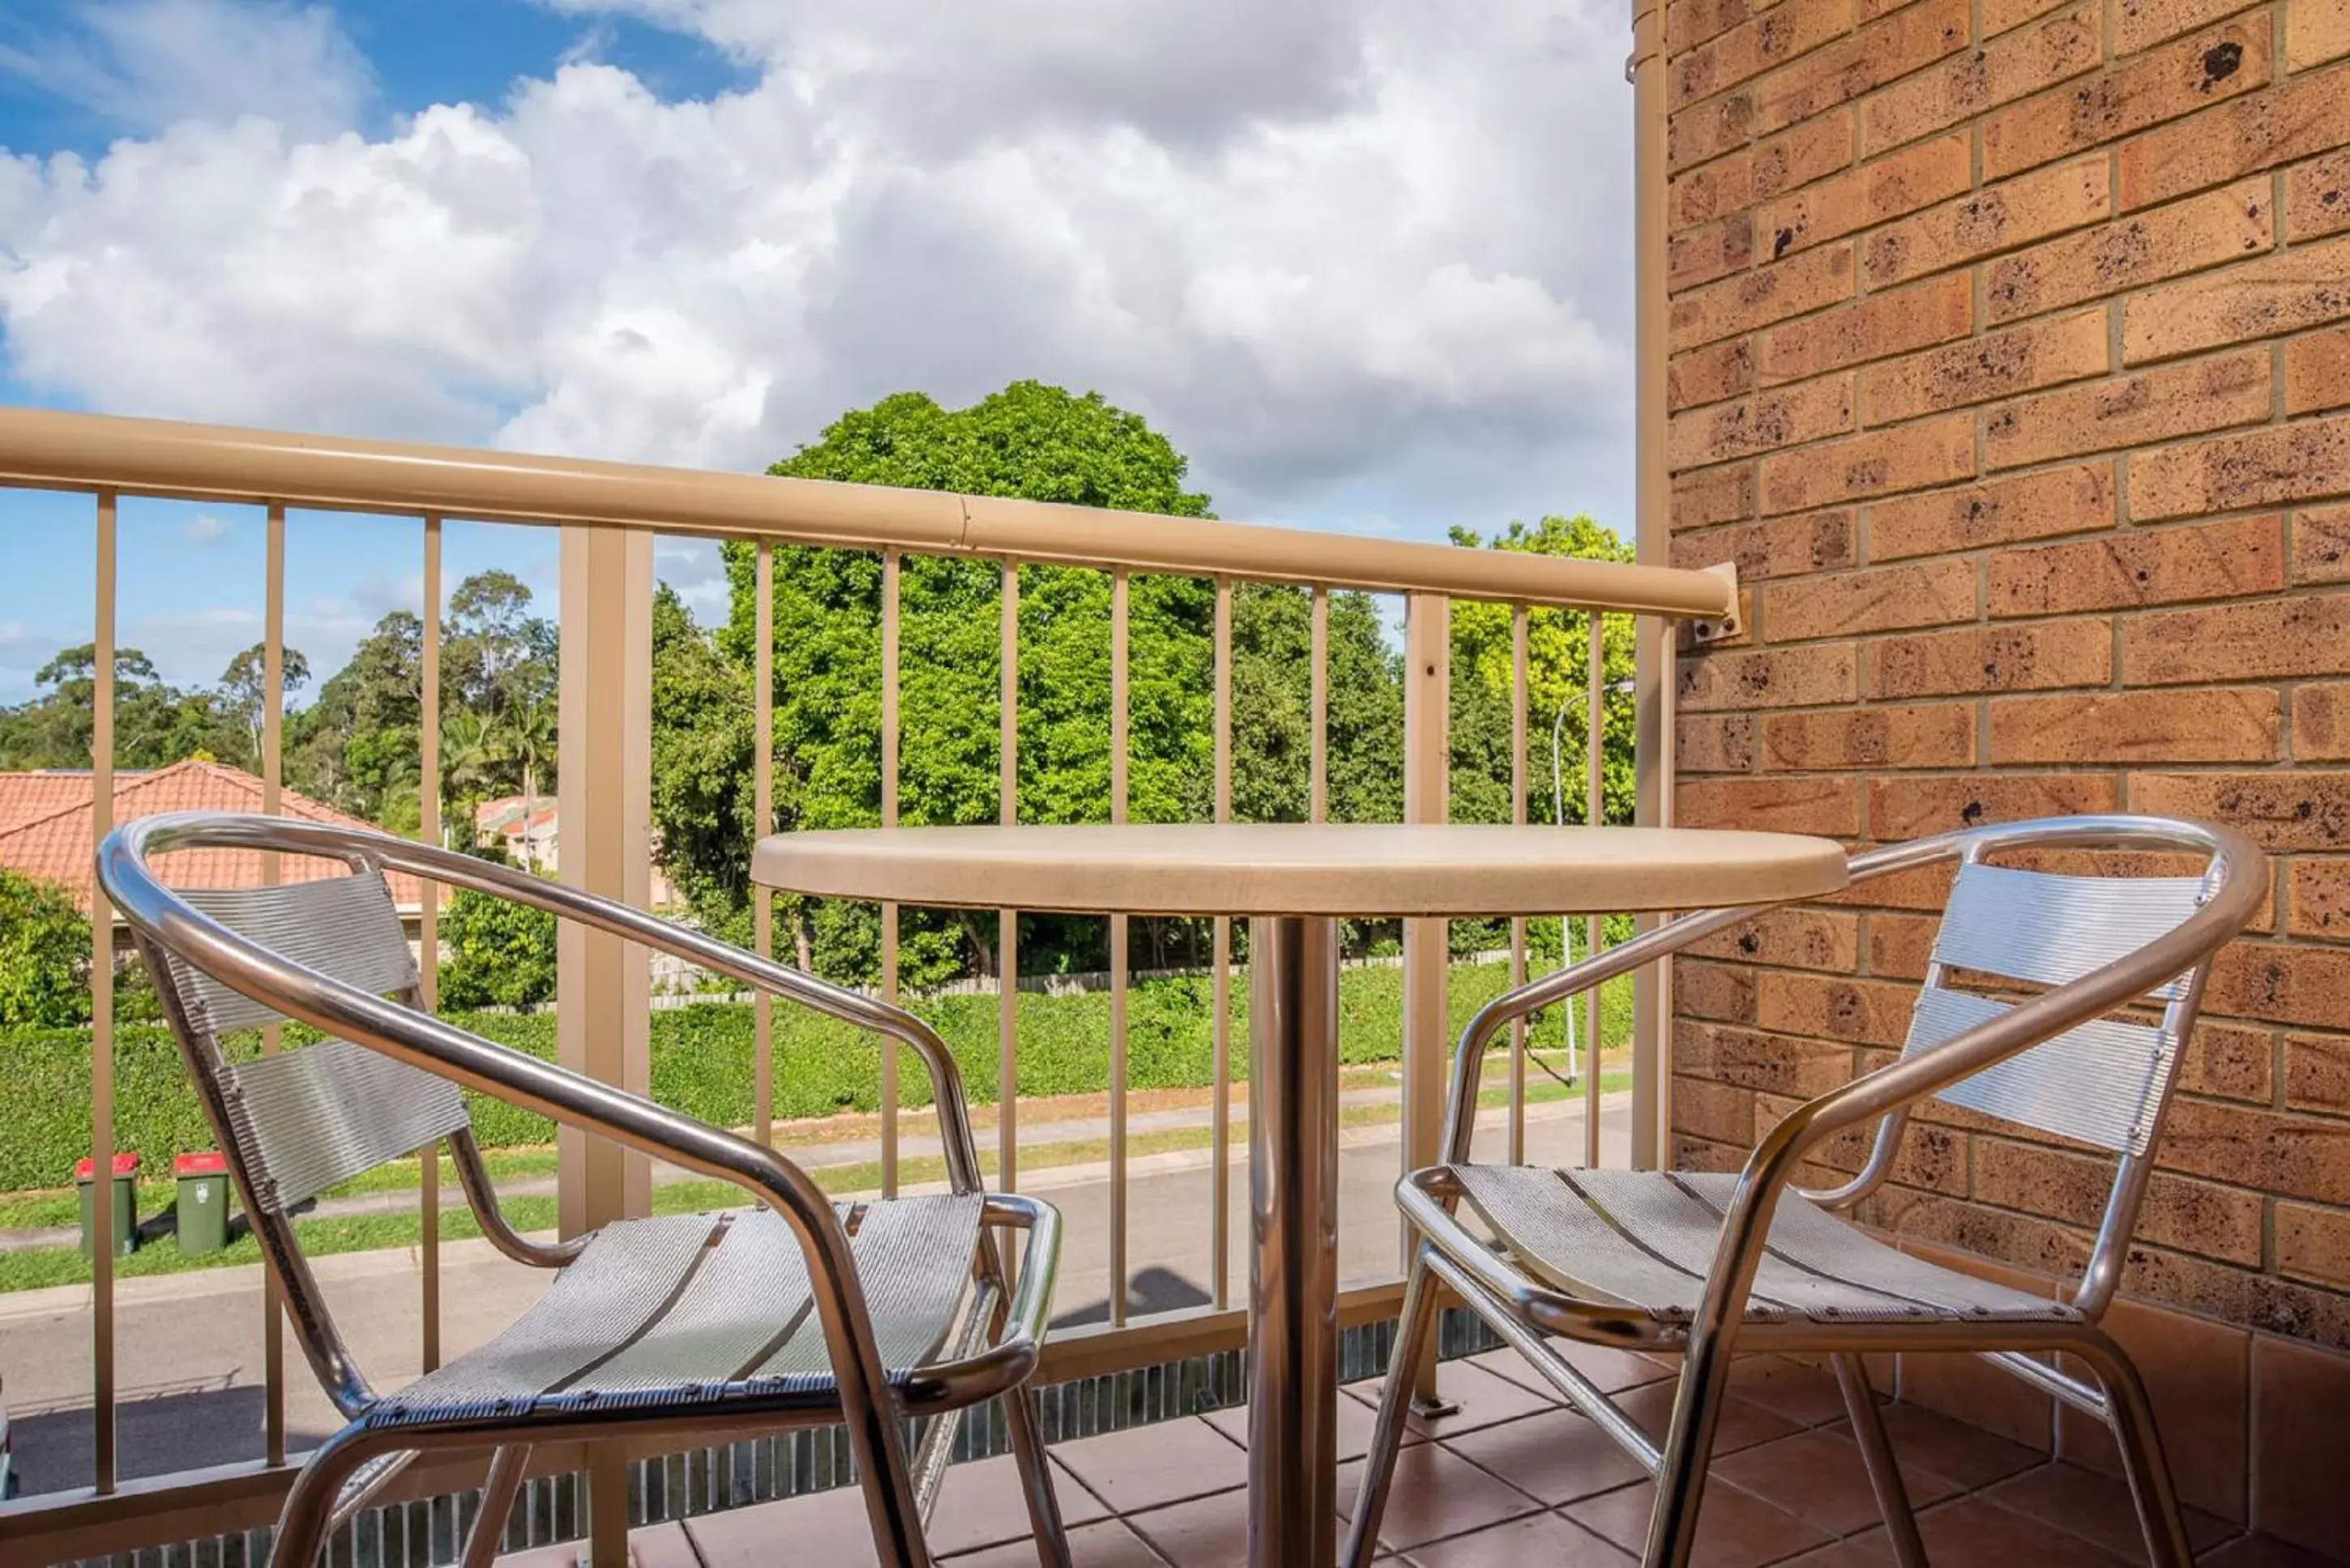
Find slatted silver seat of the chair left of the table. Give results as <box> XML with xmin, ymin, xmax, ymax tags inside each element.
<box><xmin>365</xmin><ymin>1194</ymin><xmax>985</xmax><ymax>1425</ymax></box>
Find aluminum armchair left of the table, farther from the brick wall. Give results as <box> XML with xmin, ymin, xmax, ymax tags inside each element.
<box><xmin>99</xmin><ymin>814</ymin><xmax>1070</xmax><ymax>1568</ymax></box>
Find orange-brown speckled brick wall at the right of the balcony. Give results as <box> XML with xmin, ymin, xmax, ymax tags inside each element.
<box><xmin>1666</xmin><ymin>0</ymin><xmax>2350</xmax><ymax>1542</ymax></box>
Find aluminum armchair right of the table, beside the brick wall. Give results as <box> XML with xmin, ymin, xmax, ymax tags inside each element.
<box><xmin>1342</xmin><ymin>816</ymin><xmax>2268</xmax><ymax>1568</ymax></box>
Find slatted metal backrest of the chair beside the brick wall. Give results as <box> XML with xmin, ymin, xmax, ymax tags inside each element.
<box><xmin>1904</xmin><ymin>858</ymin><xmax>2209</xmax><ymax>1156</ymax></box>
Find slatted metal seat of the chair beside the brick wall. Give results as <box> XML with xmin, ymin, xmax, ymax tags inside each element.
<box><xmin>1450</xmin><ymin>1166</ymin><xmax>2080</xmax><ymax>1323</ymax></box>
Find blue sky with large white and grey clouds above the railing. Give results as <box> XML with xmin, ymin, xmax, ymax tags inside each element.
<box><xmin>0</xmin><ymin>0</ymin><xmax>1631</xmax><ymax>703</ymax></box>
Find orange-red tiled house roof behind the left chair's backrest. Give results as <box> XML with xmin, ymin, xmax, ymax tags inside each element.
<box><xmin>0</xmin><ymin>759</ymin><xmax>439</xmax><ymax>910</ymax></box>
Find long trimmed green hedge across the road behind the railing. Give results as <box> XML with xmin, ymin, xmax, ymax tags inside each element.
<box><xmin>0</xmin><ymin>963</ymin><xmax>1631</xmax><ymax>1192</ymax></box>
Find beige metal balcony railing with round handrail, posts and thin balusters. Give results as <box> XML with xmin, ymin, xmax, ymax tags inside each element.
<box><xmin>0</xmin><ymin>409</ymin><xmax>1737</xmax><ymax>1563</ymax></box>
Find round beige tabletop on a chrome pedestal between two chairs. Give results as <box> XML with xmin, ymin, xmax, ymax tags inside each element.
<box><xmin>750</xmin><ymin>822</ymin><xmax>1845</xmax><ymax>916</ymax></box>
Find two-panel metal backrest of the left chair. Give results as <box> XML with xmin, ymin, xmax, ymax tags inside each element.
<box><xmin>148</xmin><ymin>869</ymin><xmax>468</xmax><ymax>1216</ymax></box>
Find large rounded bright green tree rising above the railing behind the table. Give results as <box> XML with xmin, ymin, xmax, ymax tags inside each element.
<box><xmin>656</xmin><ymin>381</ymin><xmax>1215</xmax><ymax>983</ymax></box>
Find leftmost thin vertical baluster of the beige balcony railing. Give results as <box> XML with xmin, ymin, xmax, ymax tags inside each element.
<box><xmin>89</xmin><ymin>491</ymin><xmax>115</xmax><ymax>1493</ymax></box>
